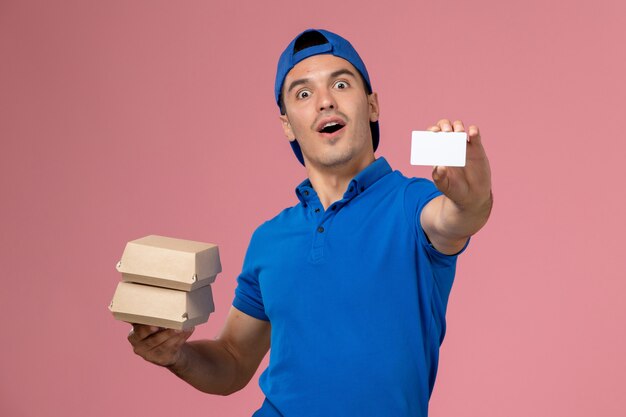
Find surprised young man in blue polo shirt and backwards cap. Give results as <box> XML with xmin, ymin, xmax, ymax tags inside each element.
<box><xmin>129</xmin><ymin>30</ymin><xmax>492</xmax><ymax>417</ymax></box>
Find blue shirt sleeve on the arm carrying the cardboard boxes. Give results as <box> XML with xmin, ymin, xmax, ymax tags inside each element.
<box><xmin>233</xmin><ymin>229</ymin><xmax>269</xmax><ymax>321</ymax></box>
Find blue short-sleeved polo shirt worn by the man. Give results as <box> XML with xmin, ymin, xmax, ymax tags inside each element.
<box><xmin>233</xmin><ymin>158</ymin><xmax>466</xmax><ymax>417</ymax></box>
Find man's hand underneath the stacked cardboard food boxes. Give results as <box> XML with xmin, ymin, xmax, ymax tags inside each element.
<box><xmin>128</xmin><ymin>324</ymin><xmax>194</xmax><ymax>367</ymax></box>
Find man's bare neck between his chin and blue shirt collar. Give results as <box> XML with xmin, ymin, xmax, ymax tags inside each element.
<box><xmin>307</xmin><ymin>154</ymin><xmax>375</xmax><ymax>210</ymax></box>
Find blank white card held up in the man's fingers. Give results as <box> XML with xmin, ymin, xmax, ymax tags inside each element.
<box><xmin>411</xmin><ymin>130</ymin><xmax>467</xmax><ymax>167</ymax></box>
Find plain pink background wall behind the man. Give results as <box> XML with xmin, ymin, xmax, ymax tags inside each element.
<box><xmin>0</xmin><ymin>0</ymin><xmax>626</xmax><ymax>417</ymax></box>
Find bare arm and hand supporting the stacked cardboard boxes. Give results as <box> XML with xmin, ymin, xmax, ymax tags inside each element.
<box><xmin>128</xmin><ymin>307</ymin><xmax>271</xmax><ymax>395</ymax></box>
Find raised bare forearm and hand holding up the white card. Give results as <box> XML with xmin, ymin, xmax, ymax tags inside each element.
<box><xmin>420</xmin><ymin>119</ymin><xmax>493</xmax><ymax>254</ymax></box>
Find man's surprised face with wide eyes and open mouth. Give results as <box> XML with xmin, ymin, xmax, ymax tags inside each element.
<box><xmin>281</xmin><ymin>55</ymin><xmax>378</xmax><ymax>168</ymax></box>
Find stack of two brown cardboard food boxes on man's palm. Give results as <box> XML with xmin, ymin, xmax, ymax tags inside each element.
<box><xmin>109</xmin><ymin>235</ymin><xmax>222</xmax><ymax>330</ymax></box>
